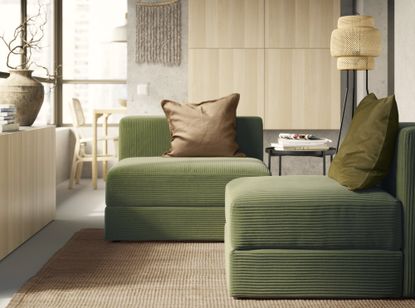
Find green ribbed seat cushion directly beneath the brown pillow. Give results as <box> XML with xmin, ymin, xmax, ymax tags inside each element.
<box><xmin>106</xmin><ymin>157</ymin><xmax>269</xmax><ymax>207</ymax></box>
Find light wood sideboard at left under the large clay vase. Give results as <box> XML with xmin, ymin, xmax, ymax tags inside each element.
<box><xmin>0</xmin><ymin>126</ymin><xmax>56</xmax><ymax>259</ymax></box>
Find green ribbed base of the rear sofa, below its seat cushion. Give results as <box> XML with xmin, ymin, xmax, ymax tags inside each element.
<box><xmin>105</xmin><ymin>207</ymin><xmax>225</xmax><ymax>242</ymax></box>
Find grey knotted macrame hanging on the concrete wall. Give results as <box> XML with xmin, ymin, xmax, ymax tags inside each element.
<box><xmin>136</xmin><ymin>0</ymin><xmax>181</xmax><ymax>65</ymax></box>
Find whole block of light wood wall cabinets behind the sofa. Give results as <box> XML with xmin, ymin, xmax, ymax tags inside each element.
<box><xmin>188</xmin><ymin>0</ymin><xmax>340</xmax><ymax>129</ymax></box>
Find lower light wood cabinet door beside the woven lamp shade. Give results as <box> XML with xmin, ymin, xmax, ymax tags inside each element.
<box><xmin>265</xmin><ymin>49</ymin><xmax>340</xmax><ymax>129</ymax></box>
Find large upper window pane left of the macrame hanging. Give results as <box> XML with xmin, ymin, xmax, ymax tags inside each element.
<box><xmin>63</xmin><ymin>0</ymin><xmax>127</xmax><ymax>80</ymax></box>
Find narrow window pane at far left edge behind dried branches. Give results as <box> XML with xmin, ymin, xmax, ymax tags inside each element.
<box><xmin>0</xmin><ymin>0</ymin><xmax>20</xmax><ymax>72</ymax></box>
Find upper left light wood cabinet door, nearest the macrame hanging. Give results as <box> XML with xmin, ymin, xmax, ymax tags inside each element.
<box><xmin>189</xmin><ymin>0</ymin><xmax>264</xmax><ymax>48</ymax></box>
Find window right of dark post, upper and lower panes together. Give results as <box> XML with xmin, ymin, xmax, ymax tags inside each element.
<box><xmin>62</xmin><ymin>0</ymin><xmax>127</xmax><ymax>124</ymax></box>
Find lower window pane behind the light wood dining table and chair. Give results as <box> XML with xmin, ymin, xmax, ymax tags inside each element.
<box><xmin>62</xmin><ymin>84</ymin><xmax>127</xmax><ymax>124</ymax></box>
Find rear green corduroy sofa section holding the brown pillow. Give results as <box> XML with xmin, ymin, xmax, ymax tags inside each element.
<box><xmin>105</xmin><ymin>116</ymin><xmax>269</xmax><ymax>241</ymax></box>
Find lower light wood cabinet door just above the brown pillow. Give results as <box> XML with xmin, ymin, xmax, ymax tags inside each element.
<box><xmin>188</xmin><ymin>49</ymin><xmax>264</xmax><ymax>116</ymax></box>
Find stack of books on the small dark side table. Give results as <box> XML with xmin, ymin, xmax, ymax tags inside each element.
<box><xmin>271</xmin><ymin>133</ymin><xmax>331</xmax><ymax>151</ymax></box>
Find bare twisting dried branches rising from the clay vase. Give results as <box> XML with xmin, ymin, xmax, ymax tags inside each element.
<box><xmin>0</xmin><ymin>0</ymin><xmax>50</xmax><ymax>70</ymax></box>
